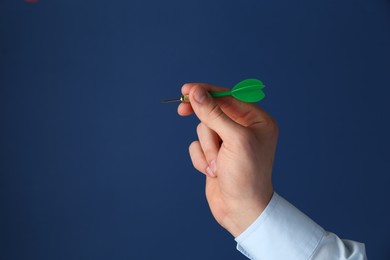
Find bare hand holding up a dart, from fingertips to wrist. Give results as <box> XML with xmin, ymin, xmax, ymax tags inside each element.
<box><xmin>178</xmin><ymin>83</ymin><xmax>278</xmax><ymax>237</ymax></box>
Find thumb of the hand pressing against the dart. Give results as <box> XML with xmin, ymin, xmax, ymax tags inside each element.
<box><xmin>189</xmin><ymin>85</ymin><xmax>243</xmax><ymax>140</ymax></box>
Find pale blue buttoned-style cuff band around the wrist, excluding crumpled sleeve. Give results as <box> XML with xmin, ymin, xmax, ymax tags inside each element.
<box><xmin>235</xmin><ymin>192</ymin><xmax>325</xmax><ymax>260</ymax></box>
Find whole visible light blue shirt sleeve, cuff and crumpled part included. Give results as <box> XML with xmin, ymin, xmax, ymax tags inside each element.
<box><xmin>235</xmin><ymin>193</ymin><xmax>367</xmax><ymax>260</ymax></box>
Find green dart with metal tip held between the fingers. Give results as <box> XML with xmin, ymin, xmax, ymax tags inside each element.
<box><xmin>161</xmin><ymin>79</ymin><xmax>265</xmax><ymax>103</ymax></box>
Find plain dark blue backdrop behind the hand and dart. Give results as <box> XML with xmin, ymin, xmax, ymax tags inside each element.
<box><xmin>0</xmin><ymin>0</ymin><xmax>390</xmax><ymax>259</ymax></box>
